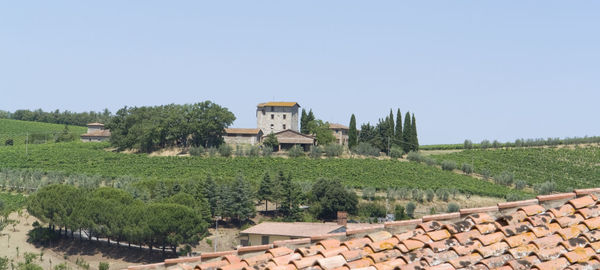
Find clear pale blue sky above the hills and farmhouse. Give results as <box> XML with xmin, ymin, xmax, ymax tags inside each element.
<box><xmin>0</xmin><ymin>1</ymin><xmax>600</xmax><ymax>144</ymax></box>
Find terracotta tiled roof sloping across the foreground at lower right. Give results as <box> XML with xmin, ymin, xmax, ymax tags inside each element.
<box><xmin>127</xmin><ymin>189</ymin><xmax>600</xmax><ymax>270</ymax></box>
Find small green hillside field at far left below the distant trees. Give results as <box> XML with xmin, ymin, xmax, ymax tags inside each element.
<box><xmin>0</xmin><ymin>119</ymin><xmax>87</xmax><ymax>146</ymax></box>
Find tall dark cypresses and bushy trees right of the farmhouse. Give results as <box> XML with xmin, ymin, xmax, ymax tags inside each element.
<box><xmin>348</xmin><ymin>109</ymin><xmax>419</xmax><ymax>156</ymax></box>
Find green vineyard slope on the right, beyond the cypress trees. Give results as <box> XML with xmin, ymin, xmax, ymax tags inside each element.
<box><xmin>432</xmin><ymin>147</ymin><xmax>600</xmax><ymax>191</ymax></box>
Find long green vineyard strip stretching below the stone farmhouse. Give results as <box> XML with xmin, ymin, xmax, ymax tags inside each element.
<box><xmin>0</xmin><ymin>142</ymin><xmax>520</xmax><ymax>197</ymax></box>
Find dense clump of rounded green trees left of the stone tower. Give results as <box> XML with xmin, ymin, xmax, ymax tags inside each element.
<box><xmin>107</xmin><ymin>101</ymin><xmax>235</xmax><ymax>152</ymax></box>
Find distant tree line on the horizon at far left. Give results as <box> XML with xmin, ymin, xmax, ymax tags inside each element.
<box><xmin>0</xmin><ymin>109</ymin><xmax>112</xmax><ymax>126</ymax></box>
